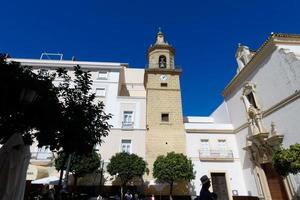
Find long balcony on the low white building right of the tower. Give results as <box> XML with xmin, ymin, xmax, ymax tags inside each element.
<box><xmin>199</xmin><ymin>149</ymin><xmax>234</xmax><ymax>161</ymax></box>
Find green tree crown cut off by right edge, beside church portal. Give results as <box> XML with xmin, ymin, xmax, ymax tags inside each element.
<box><xmin>272</xmin><ymin>143</ymin><xmax>300</xmax><ymax>176</ymax></box>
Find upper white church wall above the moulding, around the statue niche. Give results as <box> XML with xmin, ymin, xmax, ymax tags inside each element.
<box><xmin>225</xmin><ymin>47</ymin><xmax>300</xmax><ymax>128</ymax></box>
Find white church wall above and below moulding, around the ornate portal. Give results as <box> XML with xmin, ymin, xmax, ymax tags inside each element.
<box><xmin>225</xmin><ymin>45</ymin><xmax>300</xmax><ymax>195</ymax></box>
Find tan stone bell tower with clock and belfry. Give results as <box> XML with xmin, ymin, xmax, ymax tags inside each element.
<box><xmin>145</xmin><ymin>31</ymin><xmax>185</xmax><ymax>180</ymax></box>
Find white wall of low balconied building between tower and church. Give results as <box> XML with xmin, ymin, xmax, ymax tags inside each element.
<box><xmin>186</xmin><ymin>133</ymin><xmax>247</xmax><ymax>196</ymax></box>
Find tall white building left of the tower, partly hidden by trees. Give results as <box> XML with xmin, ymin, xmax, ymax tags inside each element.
<box><xmin>8</xmin><ymin>59</ymin><xmax>146</xmax><ymax>185</ymax></box>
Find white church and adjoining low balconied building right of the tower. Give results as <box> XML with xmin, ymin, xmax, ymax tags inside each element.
<box><xmin>185</xmin><ymin>34</ymin><xmax>300</xmax><ymax>200</ymax></box>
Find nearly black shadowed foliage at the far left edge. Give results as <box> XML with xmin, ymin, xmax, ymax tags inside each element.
<box><xmin>0</xmin><ymin>55</ymin><xmax>61</xmax><ymax>146</ymax></box>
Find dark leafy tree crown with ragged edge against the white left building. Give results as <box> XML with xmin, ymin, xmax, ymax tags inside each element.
<box><xmin>53</xmin><ymin>66</ymin><xmax>111</xmax><ymax>155</ymax></box>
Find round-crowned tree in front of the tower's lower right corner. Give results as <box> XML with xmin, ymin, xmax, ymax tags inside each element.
<box><xmin>153</xmin><ymin>152</ymin><xmax>195</xmax><ymax>199</ymax></box>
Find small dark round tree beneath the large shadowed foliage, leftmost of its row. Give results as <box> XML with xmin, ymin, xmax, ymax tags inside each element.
<box><xmin>55</xmin><ymin>150</ymin><xmax>100</xmax><ymax>188</ymax></box>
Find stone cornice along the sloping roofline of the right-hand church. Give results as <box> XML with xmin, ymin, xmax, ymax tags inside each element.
<box><xmin>222</xmin><ymin>33</ymin><xmax>300</xmax><ymax>97</ymax></box>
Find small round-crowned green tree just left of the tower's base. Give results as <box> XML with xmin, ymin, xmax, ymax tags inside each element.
<box><xmin>107</xmin><ymin>152</ymin><xmax>147</xmax><ymax>199</ymax></box>
